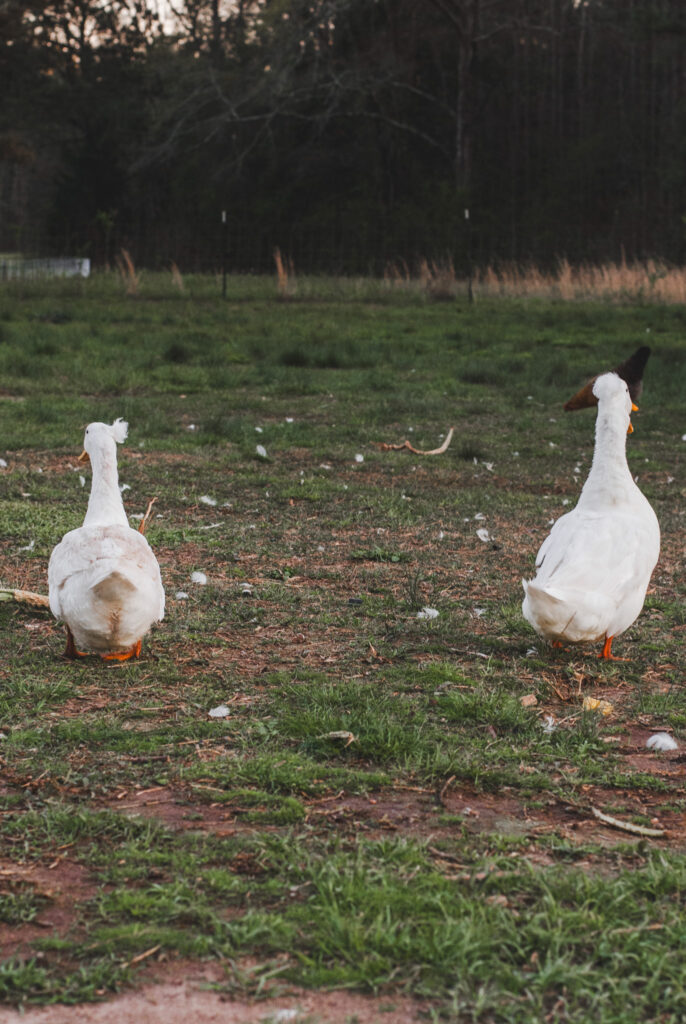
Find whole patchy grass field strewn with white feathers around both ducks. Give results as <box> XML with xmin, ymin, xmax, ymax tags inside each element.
<box><xmin>0</xmin><ymin>274</ymin><xmax>686</xmax><ymax>1024</ymax></box>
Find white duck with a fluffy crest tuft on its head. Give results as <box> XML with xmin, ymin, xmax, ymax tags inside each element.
<box><xmin>48</xmin><ymin>419</ymin><xmax>165</xmax><ymax>660</ymax></box>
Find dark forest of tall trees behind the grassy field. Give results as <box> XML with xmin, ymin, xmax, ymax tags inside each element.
<box><xmin>0</xmin><ymin>0</ymin><xmax>686</xmax><ymax>273</ymax></box>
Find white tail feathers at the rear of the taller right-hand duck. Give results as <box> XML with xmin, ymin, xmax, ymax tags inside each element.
<box><xmin>521</xmin><ymin>580</ymin><xmax>612</xmax><ymax>643</ymax></box>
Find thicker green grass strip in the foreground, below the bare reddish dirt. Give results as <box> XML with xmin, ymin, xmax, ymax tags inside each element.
<box><xmin>2</xmin><ymin>809</ymin><xmax>686</xmax><ymax>1022</ymax></box>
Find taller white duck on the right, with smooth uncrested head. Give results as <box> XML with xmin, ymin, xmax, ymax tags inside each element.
<box><xmin>522</xmin><ymin>373</ymin><xmax>659</xmax><ymax>658</ymax></box>
